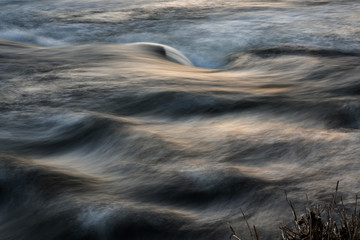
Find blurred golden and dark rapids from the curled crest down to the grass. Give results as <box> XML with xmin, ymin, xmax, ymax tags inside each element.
<box><xmin>0</xmin><ymin>36</ymin><xmax>360</xmax><ymax>240</ymax></box>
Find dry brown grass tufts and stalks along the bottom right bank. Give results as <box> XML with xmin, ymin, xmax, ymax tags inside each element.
<box><xmin>229</xmin><ymin>182</ymin><xmax>360</xmax><ymax>240</ymax></box>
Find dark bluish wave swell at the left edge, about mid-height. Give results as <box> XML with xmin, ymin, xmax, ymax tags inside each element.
<box><xmin>0</xmin><ymin>111</ymin><xmax>138</xmax><ymax>154</ymax></box>
